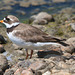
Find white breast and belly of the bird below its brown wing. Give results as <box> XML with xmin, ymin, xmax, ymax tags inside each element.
<box><xmin>7</xmin><ymin>32</ymin><xmax>60</xmax><ymax>48</ymax></box>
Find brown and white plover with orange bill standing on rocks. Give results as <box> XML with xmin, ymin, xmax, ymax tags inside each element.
<box><xmin>0</xmin><ymin>15</ymin><xmax>67</xmax><ymax>59</ymax></box>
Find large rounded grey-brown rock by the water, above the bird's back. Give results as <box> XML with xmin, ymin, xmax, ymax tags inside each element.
<box><xmin>29</xmin><ymin>12</ymin><xmax>55</xmax><ymax>25</ymax></box>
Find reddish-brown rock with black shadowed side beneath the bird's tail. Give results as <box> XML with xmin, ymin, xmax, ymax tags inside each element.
<box><xmin>37</xmin><ymin>45</ymin><xmax>62</xmax><ymax>58</ymax></box>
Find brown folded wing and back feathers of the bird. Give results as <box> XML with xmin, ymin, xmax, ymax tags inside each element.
<box><xmin>14</xmin><ymin>24</ymin><xmax>68</xmax><ymax>44</ymax></box>
